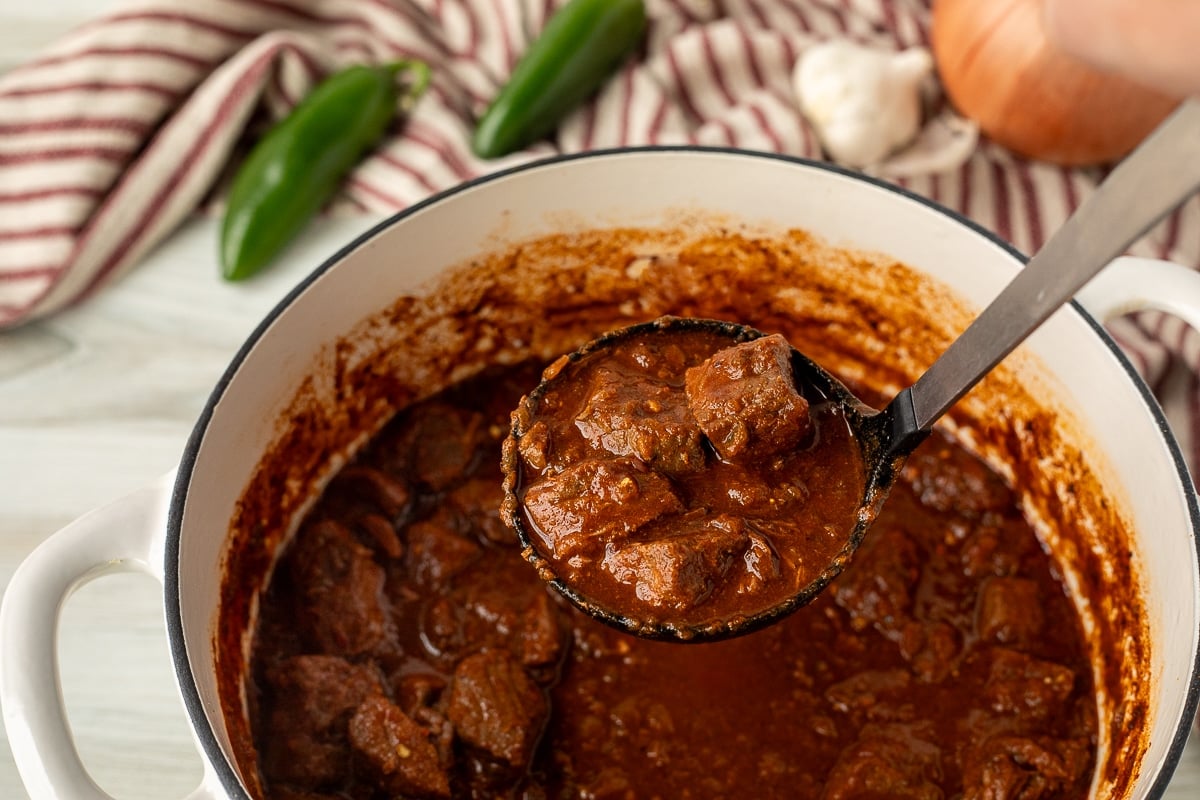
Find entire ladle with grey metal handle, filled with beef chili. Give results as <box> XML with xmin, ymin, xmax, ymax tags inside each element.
<box><xmin>500</xmin><ymin>100</ymin><xmax>1200</xmax><ymax>642</ymax></box>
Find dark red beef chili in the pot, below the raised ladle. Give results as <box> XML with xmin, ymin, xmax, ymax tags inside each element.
<box><xmin>247</xmin><ymin>366</ymin><xmax>1097</xmax><ymax>800</ymax></box>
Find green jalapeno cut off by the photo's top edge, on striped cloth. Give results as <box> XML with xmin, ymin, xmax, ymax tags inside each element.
<box><xmin>470</xmin><ymin>0</ymin><xmax>646</xmax><ymax>158</ymax></box>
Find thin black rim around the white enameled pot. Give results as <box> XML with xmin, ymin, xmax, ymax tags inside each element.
<box><xmin>163</xmin><ymin>145</ymin><xmax>1200</xmax><ymax>800</ymax></box>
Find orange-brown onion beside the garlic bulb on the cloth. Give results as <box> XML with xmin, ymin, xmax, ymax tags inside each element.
<box><xmin>931</xmin><ymin>0</ymin><xmax>1180</xmax><ymax>167</ymax></box>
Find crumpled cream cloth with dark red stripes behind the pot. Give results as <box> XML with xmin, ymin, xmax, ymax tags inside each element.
<box><xmin>7</xmin><ymin>0</ymin><xmax>1200</xmax><ymax>463</ymax></box>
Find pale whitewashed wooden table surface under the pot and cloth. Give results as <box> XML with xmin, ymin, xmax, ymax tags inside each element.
<box><xmin>0</xmin><ymin>0</ymin><xmax>1200</xmax><ymax>800</ymax></box>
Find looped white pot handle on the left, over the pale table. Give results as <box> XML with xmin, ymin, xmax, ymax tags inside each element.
<box><xmin>0</xmin><ymin>471</ymin><xmax>223</xmax><ymax>800</ymax></box>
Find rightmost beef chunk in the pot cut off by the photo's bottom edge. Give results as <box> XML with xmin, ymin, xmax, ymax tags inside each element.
<box><xmin>962</xmin><ymin>735</ymin><xmax>1090</xmax><ymax>800</ymax></box>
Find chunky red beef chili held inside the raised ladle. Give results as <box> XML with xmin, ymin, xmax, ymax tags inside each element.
<box><xmin>504</xmin><ymin>326</ymin><xmax>864</xmax><ymax>631</ymax></box>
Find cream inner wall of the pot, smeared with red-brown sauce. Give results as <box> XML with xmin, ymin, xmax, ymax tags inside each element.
<box><xmin>168</xmin><ymin>150</ymin><xmax>1200</xmax><ymax>798</ymax></box>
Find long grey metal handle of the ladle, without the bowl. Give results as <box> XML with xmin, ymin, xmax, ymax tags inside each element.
<box><xmin>888</xmin><ymin>98</ymin><xmax>1200</xmax><ymax>452</ymax></box>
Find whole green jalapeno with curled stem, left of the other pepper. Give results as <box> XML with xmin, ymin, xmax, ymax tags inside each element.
<box><xmin>221</xmin><ymin>61</ymin><xmax>430</xmax><ymax>281</ymax></box>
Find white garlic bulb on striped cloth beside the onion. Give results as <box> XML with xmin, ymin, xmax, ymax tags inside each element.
<box><xmin>792</xmin><ymin>40</ymin><xmax>934</xmax><ymax>169</ymax></box>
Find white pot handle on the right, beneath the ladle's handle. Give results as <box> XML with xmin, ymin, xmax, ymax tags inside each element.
<box><xmin>1075</xmin><ymin>255</ymin><xmax>1200</xmax><ymax>330</ymax></box>
